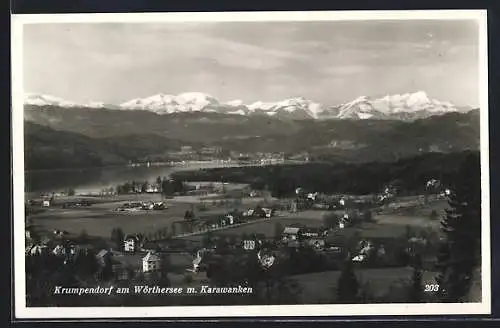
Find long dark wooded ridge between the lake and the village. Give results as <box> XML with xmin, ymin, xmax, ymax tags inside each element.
<box><xmin>173</xmin><ymin>151</ymin><xmax>477</xmax><ymax>198</ymax></box>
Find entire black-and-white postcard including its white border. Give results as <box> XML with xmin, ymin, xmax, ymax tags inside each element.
<box><xmin>12</xmin><ymin>10</ymin><xmax>491</xmax><ymax>318</ymax></box>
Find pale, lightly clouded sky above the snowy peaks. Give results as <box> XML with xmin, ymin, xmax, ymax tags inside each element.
<box><xmin>23</xmin><ymin>20</ymin><xmax>479</xmax><ymax>106</ymax></box>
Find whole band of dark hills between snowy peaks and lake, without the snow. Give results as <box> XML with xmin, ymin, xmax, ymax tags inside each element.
<box><xmin>25</xmin><ymin>106</ymin><xmax>480</xmax><ymax>167</ymax></box>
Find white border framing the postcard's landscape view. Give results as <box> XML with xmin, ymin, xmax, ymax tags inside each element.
<box><xmin>11</xmin><ymin>10</ymin><xmax>491</xmax><ymax>319</ymax></box>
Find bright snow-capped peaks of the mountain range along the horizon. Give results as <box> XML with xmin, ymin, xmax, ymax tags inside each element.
<box><xmin>24</xmin><ymin>91</ymin><xmax>472</xmax><ymax>120</ymax></box>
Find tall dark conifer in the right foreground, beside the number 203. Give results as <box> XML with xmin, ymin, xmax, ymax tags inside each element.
<box><xmin>436</xmin><ymin>154</ymin><xmax>481</xmax><ymax>302</ymax></box>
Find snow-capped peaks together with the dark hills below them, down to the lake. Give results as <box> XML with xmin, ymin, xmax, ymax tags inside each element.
<box><xmin>24</xmin><ymin>92</ymin><xmax>480</xmax><ymax>169</ymax></box>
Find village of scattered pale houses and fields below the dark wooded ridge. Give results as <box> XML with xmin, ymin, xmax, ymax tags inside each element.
<box><xmin>26</xmin><ymin>174</ymin><xmax>451</xmax><ymax>304</ymax></box>
